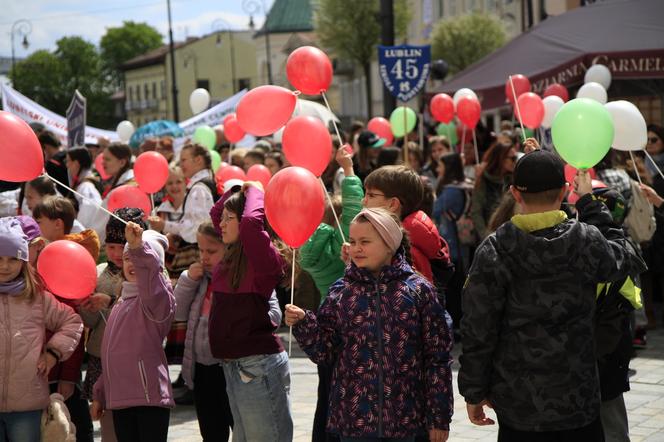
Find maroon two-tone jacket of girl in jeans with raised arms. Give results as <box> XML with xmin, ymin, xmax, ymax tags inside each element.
<box><xmin>209</xmin><ymin>187</ymin><xmax>285</xmax><ymax>359</ymax></box>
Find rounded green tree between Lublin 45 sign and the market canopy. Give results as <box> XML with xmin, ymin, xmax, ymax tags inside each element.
<box><xmin>431</xmin><ymin>12</ymin><xmax>507</xmax><ymax>75</ymax></box>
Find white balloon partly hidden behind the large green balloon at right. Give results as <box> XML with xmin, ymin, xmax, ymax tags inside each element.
<box><xmin>604</xmin><ymin>100</ymin><xmax>648</xmax><ymax>150</ymax></box>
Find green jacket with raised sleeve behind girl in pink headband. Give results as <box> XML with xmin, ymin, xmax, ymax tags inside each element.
<box><xmin>299</xmin><ymin>176</ymin><xmax>364</xmax><ymax>303</ymax></box>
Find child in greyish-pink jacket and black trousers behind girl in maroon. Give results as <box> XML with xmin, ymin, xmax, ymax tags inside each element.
<box><xmin>175</xmin><ymin>223</ymin><xmax>281</xmax><ymax>441</ymax></box>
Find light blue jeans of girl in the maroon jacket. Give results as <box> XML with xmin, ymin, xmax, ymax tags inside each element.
<box><xmin>223</xmin><ymin>351</ymin><xmax>293</xmax><ymax>442</ymax></box>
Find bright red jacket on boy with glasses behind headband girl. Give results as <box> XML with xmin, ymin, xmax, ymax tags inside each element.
<box><xmin>403</xmin><ymin>210</ymin><xmax>450</xmax><ymax>283</ymax></box>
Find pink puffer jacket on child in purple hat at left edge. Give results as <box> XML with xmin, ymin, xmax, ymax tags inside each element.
<box><xmin>0</xmin><ymin>292</ymin><xmax>83</xmax><ymax>413</ymax></box>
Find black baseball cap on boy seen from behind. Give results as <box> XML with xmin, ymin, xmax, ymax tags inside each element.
<box><xmin>514</xmin><ymin>149</ymin><xmax>566</xmax><ymax>193</ymax></box>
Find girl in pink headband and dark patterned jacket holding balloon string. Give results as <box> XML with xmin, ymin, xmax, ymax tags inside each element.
<box><xmin>286</xmin><ymin>209</ymin><xmax>453</xmax><ymax>442</ymax></box>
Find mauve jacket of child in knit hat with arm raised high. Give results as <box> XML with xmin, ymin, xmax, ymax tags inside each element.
<box><xmin>93</xmin><ymin>243</ymin><xmax>175</xmax><ymax>410</ymax></box>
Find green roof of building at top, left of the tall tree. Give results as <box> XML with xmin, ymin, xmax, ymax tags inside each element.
<box><xmin>255</xmin><ymin>0</ymin><xmax>314</xmax><ymax>37</ymax></box>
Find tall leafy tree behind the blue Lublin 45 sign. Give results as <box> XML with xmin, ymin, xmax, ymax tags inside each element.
<box><xmin>314</xmin><ymin>0</ymin><xmax>410</xmax><ymax>113</ymax></box>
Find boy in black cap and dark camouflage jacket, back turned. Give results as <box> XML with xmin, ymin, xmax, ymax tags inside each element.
<box><xmin>459</xmin><ymin>150</ymin><xmax>645</xmax><ymax>442</ymax></box>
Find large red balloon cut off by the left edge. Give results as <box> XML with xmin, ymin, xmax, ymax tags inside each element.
<box><xmin>0</xmin><ymin>111</ymin><xmax>44</xmax><ymax>183</ymax></box>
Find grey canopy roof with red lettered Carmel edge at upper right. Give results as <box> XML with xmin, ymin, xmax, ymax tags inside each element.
<box><xmin>439</xmin><ymin>0</ymin><xmax>664</xmax><ymax>110</ymax></box>
